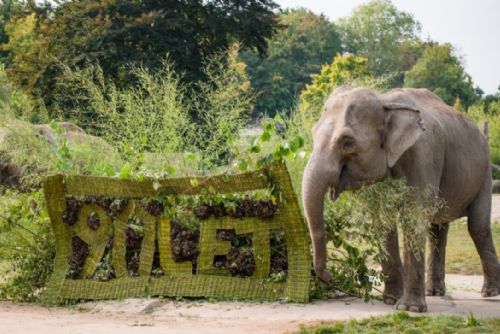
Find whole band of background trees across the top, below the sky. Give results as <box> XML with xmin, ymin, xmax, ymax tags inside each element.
<box><xmin>0</xmin><ymin>0</ymin><xmax>488</xmax><ymax>119</ymax></box>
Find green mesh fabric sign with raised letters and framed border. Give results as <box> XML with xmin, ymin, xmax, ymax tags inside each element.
<box><xmin>44</xmin><ymin>162</ymin><xmax>311</xmax><ymax>304</ymax></box>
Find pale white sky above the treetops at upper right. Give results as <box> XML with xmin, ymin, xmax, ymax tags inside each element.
<box><xmin>275</xmin><ymin>0</ymin><xmax>500</xmax><ymax>94</ymax></box>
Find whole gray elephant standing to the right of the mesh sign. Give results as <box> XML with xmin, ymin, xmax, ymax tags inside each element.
<box><xmin>302</xmin><ymin>87</ymin><xmax>500</xmax><ymax>312</ymax></box>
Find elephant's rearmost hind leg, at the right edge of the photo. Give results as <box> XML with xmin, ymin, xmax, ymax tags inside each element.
<box><xmin>467</xmin><ymin>173</ymin><xmax>500</xmax><ymax>297</ymax></box>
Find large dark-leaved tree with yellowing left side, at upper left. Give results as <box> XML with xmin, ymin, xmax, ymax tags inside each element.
<box><xmin>1</xmin><ymin>0</ymin><xmax>279</xmax><ymax>111</ymax></box>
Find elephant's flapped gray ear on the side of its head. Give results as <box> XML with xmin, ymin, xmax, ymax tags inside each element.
<box><xmin>384</xmin><ymin>103</ymin><xmax>425</xmax><ymax>168</ymax></box>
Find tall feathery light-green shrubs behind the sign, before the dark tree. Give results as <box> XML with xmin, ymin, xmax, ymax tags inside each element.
<box><xmin>56</xmin><ymin>45</ymin><xmax>253</xmax><ymax>171</ymax></box>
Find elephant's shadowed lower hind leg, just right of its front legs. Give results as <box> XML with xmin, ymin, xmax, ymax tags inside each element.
<box><xmin>426</xmin><ymin>223</ymin><xmax>450</xmax><ymax>296</ymax></box>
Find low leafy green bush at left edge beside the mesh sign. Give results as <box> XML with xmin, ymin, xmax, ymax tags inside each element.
<box><xmin>0</xmin><ymin>190</ymin><xmax>55</xmax><ymax>301</ymax></box>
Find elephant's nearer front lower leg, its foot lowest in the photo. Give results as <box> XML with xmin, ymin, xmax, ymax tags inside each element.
<box><xmin>396</xmin><ymin>237</ymin><xmax>427</xmax><ymax>312</ymax></box>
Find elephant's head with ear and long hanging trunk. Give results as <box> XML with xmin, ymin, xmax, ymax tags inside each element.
<box><xmin>302</xmin><ymin>87</ymin><xmax>424</xmax><ymax>281</ymax></box>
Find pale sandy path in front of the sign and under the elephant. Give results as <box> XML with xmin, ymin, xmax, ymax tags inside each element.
<box><xmin>0</xmin><ymin>275</ymin><xmax>500</xmax><ymax>334</ymax></box>
